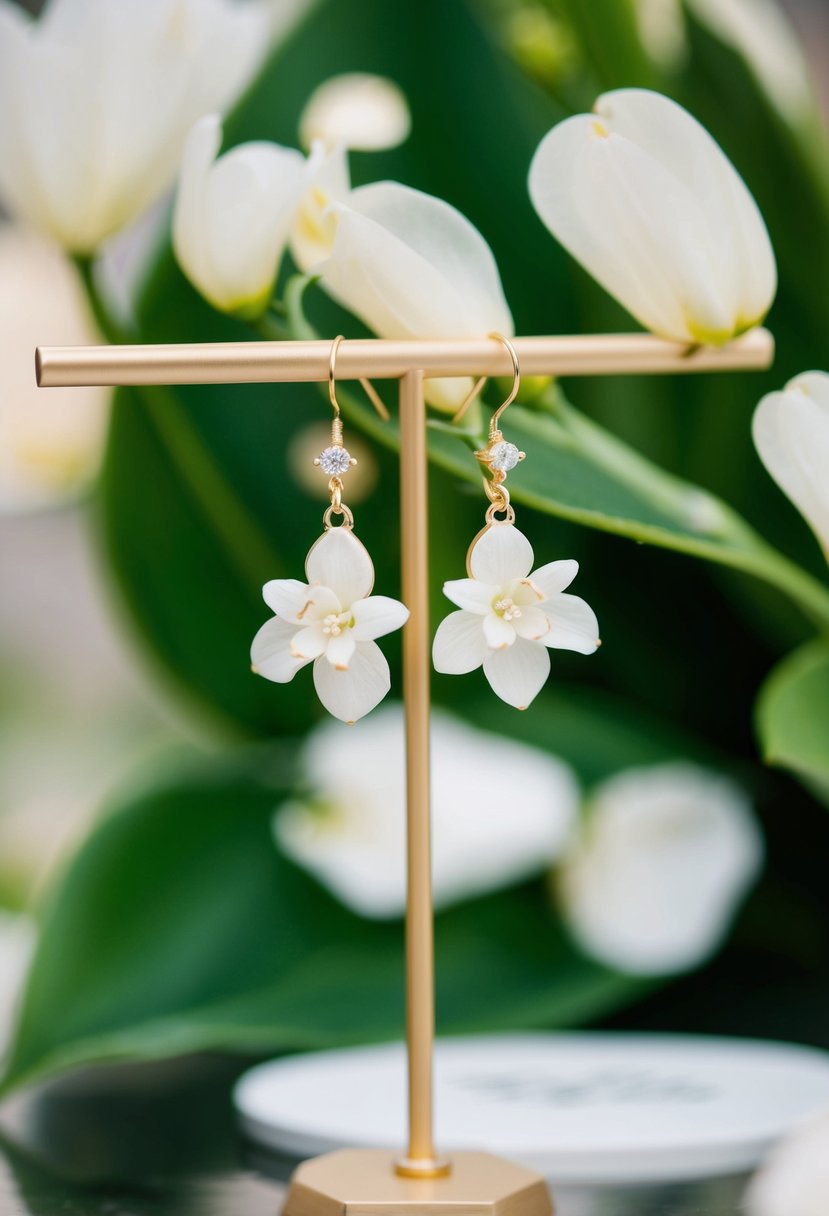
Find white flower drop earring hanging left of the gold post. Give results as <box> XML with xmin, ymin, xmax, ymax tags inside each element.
<box><xmin>250</xmin><ymin>334</ymin><xmax>408</xmax><ymax>724</ymax></box>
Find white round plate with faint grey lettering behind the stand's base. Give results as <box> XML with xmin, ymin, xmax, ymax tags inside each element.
<box><xmin>235</xmin><ymin>1032</ymin><xmax>829</xmax><ymax>1186</ymax></box>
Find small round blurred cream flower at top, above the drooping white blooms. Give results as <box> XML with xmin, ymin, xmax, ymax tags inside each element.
<box><xmin>299</xmin><ymin>72</ymin><xmax>412</xmax><ymax>152</ymax></box>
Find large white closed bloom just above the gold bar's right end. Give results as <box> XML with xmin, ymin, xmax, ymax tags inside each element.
<box><xmin>529</xmin><ymin>89</ymin><xmax>777</xmax><ymax>344</ymax></box>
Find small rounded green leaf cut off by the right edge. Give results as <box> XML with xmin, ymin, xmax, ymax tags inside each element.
<box><xmin>757</xmin><ymin>641</ymin><xmax>829</xmax><ymax>794</ymax></box>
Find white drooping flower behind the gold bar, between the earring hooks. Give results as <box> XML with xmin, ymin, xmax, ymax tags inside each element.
<box><xmin>317</xmin><ymin>181</ymin><xmax>513</xmax><ymax>410</ymax></box>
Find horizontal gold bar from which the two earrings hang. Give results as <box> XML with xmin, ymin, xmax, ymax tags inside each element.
<box><xmin>35</xmin><ymin>330</ymin><xmax>774</xmax><ymax>388</ymax></box>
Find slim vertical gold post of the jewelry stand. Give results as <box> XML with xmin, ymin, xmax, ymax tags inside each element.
<box><xmin>396</xmin><ymin>371</ymin><xmax>449</xmax><ymax>1178</ymax></box>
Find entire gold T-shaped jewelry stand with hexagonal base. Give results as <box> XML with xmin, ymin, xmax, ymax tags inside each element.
<box><xmin>35</xmin><ymin>330</ymin><xmax>774</xmax><ymax>1216</ymax></box>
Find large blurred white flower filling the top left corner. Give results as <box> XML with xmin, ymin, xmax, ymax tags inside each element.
<box><xmin>0</xmin><ymin>0</ymin><xmax>273</xmax><ymax>253</ymax></box>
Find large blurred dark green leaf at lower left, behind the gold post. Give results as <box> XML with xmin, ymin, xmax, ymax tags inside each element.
<box><xmin>4</xmin><ymin>753</ymin><xmax>643</xmax><ymax>1090</ymax></box>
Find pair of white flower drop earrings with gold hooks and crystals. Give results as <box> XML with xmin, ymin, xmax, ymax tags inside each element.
<box><xmin>250</xmin><ymin>333</ymin><xmax>599</xmax><ymax>722</ymax></box>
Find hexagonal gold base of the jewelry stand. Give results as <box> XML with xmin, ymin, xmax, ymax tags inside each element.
<box><xmin>283</xmin><ymin>1148</ymin><xmax>553</xmax><ymax>1216</ymax></box>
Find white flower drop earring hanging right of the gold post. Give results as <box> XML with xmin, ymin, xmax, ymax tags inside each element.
<box><xmin>433</xmin><ymin>333</ymin><xmax>599</xmax><ymax>709</ymax></box>
